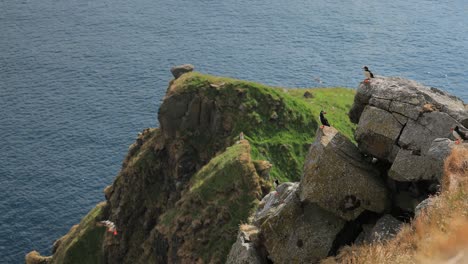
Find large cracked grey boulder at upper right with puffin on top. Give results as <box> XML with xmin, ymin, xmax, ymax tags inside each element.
<box><xmin>349</xmin><ymin>77</ymin><xmax>468</xmax><ymax>181</ymax></box>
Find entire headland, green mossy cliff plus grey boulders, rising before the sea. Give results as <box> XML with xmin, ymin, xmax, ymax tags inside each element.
<box><xmin>26</xmin><ymin>69</ymin><xmax>468</xmax><ymax>263</ymax></box>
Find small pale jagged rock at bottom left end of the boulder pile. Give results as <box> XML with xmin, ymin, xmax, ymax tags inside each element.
<box><xmin>226</xmin><ymin>225</ymin><xmax>265</xmax><ymax>264</ymax></box>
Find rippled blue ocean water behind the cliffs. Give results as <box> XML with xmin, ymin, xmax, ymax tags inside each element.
<box><xmin>0</xmin><ymin>0</ymin><xmax>468</xmax><ymax>263</ymax></box>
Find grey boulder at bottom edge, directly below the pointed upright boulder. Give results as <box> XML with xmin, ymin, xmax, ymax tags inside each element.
<box><xmin>257</xmin><ymin>184</ymin><xmax>345</xmax><ymax>263</ymax></box>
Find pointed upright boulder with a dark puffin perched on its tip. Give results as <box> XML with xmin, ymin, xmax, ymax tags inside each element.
<box><xmin>299</xmin><ymin>127</ymin><xmax>389</xmax><ymax>220</ymax></box>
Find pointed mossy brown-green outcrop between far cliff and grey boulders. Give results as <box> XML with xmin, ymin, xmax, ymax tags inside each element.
<box><xmin>160</xmin><ymin>141</ymin><xmax>261</xmax><ymax>263</ymax></box>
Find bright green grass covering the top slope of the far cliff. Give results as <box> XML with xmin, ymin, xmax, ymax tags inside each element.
<box><xmin>169</xmin><ymin>73</ymin><xmax>355</xmax><ymax>181</ymax></box>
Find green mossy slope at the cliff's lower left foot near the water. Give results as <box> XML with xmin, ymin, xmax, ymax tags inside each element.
<box><xmin>52</xmin><ymin>203</ymin><xmax>106</xmax><ymax>264</ymax></box>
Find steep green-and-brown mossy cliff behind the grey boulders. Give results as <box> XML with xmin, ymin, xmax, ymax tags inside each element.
<box><xmin>28</xmin><ymin>73</ymin><xmax>353</xmax><ymax>263</ymax></box>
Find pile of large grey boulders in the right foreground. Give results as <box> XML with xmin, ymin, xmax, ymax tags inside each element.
<box><xmin>227</xmin><ymin>78</ymin><xmax>468</xmax><ymax>263</ymax></box>
